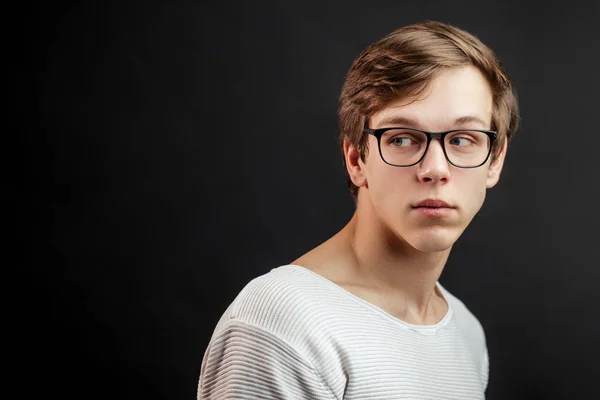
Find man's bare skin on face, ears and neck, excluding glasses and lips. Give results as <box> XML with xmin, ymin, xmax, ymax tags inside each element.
<box><xmin>292</xmin><ymin>66</ymin><xmax>506</xmax><ymax>325</ymax></box>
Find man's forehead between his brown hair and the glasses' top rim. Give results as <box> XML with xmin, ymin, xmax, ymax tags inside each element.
<box><xmin>369</xmin><ymin>66</ymin><xmax>493</xmax><ymax>130</ymax></box>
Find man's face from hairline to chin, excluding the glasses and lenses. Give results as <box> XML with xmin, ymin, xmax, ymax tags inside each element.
<box><xmin>355</xmin><ymin>67</ymin><xmax>506</xmax><ymax>252</ymax></box>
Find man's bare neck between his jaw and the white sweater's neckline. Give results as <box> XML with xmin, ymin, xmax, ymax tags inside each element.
<box><xmin>340</xmin><ymin>205</ymin><xmax>450</xmax><ymax>320</ymax></box>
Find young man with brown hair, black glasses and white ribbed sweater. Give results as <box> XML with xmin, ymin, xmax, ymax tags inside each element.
<box><xmin>198</xmin><ymin>22</ymin><xmax>518</xmax><ymax>400</ymax></box>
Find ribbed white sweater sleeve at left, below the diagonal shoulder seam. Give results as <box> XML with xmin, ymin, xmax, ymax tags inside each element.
<box><xmin>198</xmin><ymin>320</ymin><xmax>337</xmax><ymax>400</ymax></box>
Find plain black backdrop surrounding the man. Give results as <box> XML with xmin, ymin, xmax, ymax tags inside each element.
<box><xmin>19</xmin><ymin>0</ymin><xmax>600</xmax><ymax>400</ymax></box>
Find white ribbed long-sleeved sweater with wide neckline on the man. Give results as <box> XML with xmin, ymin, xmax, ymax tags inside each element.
<box><xmin>198</xmin><ymin>265</ymin><xmax>488</xmax><ymax>400</ymax></box>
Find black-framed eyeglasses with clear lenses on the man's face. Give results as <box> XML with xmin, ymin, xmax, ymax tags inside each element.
<box><xmin>364</xmin><ymin>128</ymin><xmax>496</xmax><ymax>168</ymax></box>
